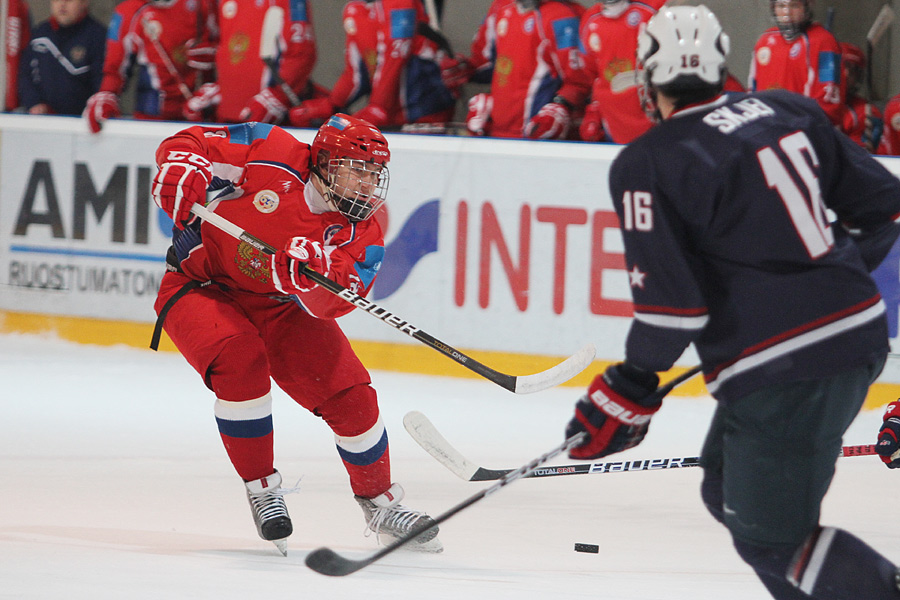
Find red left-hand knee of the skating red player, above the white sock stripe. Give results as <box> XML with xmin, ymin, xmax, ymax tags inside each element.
<box><xmin>206</xmin><ymin>335</ymin><xmax>272</xmax><ymax>401</ymax></box>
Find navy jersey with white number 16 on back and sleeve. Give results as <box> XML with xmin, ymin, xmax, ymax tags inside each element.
<box><xmin>610</xmin><ymin>91</ymin><xmax>900</xmax><ymax>399</ymax></box>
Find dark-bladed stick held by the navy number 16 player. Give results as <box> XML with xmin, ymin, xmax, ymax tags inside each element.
<box><xmin>306</xmin><ymin>432</ymin><xmax>585</xmax><ymax>577</ymax></box>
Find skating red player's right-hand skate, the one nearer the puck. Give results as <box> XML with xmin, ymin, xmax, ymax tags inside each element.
<box><xmin>354</xmin><ymin>483</ymin><xmax>444</xmax><ymax>552</ymax></box>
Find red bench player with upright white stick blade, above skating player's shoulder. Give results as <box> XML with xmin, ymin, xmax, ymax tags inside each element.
<box><xmin>185</xmin><ymin>0</ymin><xmax>327</xmax><ymax>123</ymax></box>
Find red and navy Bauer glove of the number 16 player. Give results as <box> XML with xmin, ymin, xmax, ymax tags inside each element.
<box><xmin>566</xmin><ymin>363</ymin><xmax>662</xmax><ymax>459</ymax></box>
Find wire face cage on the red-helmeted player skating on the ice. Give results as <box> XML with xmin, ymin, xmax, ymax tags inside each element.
<box><xmin>325</xmin><ymin>158</ymin><xmax>390</xmax><ymax>221</ymax></box>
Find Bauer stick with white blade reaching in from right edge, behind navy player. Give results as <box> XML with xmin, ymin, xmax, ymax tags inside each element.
<box><xmin>403</xmin><ymin>411</ymin><xmax>888</xmax><ymax>481</ymax></box>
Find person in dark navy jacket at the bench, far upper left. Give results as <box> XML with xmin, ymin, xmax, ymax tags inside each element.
<box><xmin>19</xmin><ymin>0</ymin><xmax>106</xmax><ymax>115</ymax></box>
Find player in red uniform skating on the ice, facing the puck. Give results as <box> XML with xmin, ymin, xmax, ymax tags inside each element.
<box><xmin>152</xmin><ymin>114</ymin><xmax>441</xmax><ymax>552</ymax></box>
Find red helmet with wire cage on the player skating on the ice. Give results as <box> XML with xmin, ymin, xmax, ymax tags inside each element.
<box><xmin>311</xmin><ymin>113</ymin><xmax>391</xmax><ymax>221</ymax></box>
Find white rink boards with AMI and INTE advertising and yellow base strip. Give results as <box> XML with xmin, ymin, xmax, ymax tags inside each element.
<box><xmin>0</xmin><ymin>115</ymin><xmax>900</xmax><ymax>404</ymax></box>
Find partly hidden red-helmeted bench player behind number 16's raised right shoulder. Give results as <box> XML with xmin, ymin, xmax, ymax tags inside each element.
<box><xmin>841</xmin><ymin>42</ymin><xmax>886</xmax><ymax>154</ymax></box>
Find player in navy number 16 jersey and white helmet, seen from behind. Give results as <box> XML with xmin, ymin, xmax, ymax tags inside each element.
<box><xmin>566</xmin><ymin>6</ymin><xmax>900</xmax><ymax>600</ymax></box>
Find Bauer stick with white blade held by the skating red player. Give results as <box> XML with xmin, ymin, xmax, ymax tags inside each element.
<box><xmin>191</xmin><ymin>204</ymin><xmax>595</xmax><ymax>394</ymax></box>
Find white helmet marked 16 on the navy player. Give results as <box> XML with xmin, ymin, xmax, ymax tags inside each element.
<box><xmin>637</xmin><ymin>4</ymin><xmax>730</xmax><ymax>94</ymax></box>
